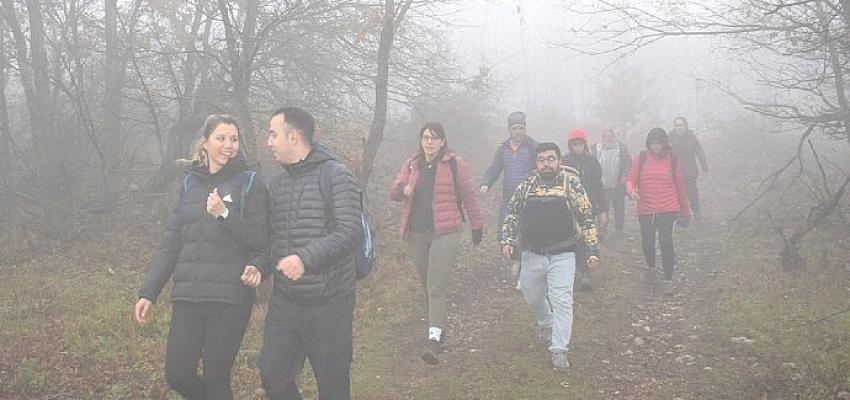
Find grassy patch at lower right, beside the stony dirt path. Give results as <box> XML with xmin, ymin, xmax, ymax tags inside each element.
<box><xmin>716</xmin><ymin>234</ymin><xmax>850</xmax><ymax>399</ymax></box>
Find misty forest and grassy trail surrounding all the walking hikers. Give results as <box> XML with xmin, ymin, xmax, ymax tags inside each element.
<box><xmin>0</xmin><ymin>0</ymin><xmax>850</xmax><ymax>400</ymax></box>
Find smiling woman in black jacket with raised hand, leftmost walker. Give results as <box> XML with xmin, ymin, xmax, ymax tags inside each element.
<box><xmin>135</xmin><ymin>115</ymin><xmax>269</xmax><ymax>400</ymax></box>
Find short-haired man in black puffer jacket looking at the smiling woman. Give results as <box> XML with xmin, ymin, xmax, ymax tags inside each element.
<box><xmin>259</xmin><ymin>107</ymin><xmax>361</xmax><ymax>400</ymax></box>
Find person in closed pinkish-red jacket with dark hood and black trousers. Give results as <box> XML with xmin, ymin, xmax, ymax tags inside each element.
<box><xmin>626</xmin><ymin>128</ymin><xmax>691</xmax><ymax>295</ymax></box>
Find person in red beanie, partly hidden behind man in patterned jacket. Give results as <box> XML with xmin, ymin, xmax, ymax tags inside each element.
<box><xmin>561</xmin><ymin>129</ymin><xmax>608</xmax><ymax>291</ymax></box>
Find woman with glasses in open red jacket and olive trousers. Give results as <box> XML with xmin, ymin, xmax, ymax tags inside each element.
<box><xmin>390</xmin><ymin>122</ymin><xmax>482</xmax><ymax>364</ymax></box>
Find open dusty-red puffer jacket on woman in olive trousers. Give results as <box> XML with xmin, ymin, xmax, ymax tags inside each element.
<box><xmin>390</xmin><ymin>150</ymin><xmax>484</xmax><ymax>239</ymax></box>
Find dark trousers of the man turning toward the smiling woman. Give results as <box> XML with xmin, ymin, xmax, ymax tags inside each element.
<box><xmin>259</xmin><ymin>293</ymin><xmax>355</xmax><ymax>400</ymax></box>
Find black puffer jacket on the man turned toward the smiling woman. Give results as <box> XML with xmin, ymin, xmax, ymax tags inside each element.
<box><xmin>269</xmin><ymin>145</ymin><xmax>361</xmax><ymax>304</ymax></box>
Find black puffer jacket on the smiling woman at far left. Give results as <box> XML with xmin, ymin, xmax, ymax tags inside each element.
<box><xmin>139</xmin><ymin>159</ymin><xmax>269</xmax><ymax>304</ymax></box>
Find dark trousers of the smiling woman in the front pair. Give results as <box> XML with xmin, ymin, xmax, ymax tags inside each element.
<box><xmin>165</xmin><ymin>301</ymin><xmax>252</xmax><ymax>400</ymax></box>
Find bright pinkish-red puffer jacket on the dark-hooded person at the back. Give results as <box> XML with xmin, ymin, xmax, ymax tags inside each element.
<box><xmin>626</xmin><ymin>151</ymin><xmax>691</xmax><ymax>218</ymax></box>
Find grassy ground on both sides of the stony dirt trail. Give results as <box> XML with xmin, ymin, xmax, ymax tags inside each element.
<box><xmin>0</xmin><ymin>223</ymin><xmax>850</xmax><ymax>400</ymax></box>
